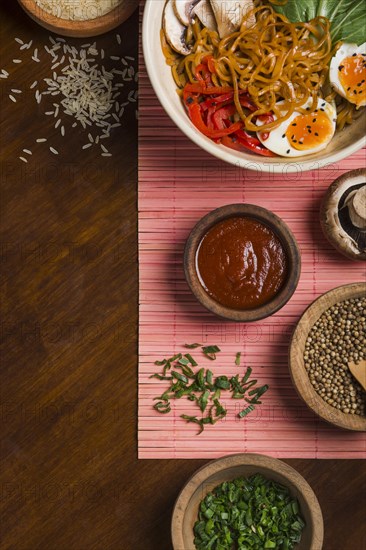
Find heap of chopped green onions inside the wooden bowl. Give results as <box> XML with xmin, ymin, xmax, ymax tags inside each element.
<box><xmin>193</xmin><ymin>474</ymin><xmax>305</xmax><ymax>550</ymax></box>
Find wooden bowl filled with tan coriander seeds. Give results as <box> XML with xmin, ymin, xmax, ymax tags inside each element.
<box><xmin>289</xmin><ymin>282</ymin><xmax>366</xmax><ymax>431</ymax></box>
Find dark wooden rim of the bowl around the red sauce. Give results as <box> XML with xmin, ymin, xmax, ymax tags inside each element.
<box><xmin>183</xmin><ymin>203</ymin><xmax>301</xmax><ymax>323</ymax></box>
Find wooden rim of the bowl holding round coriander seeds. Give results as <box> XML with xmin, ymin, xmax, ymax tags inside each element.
<box><xmin>288</xmin><ymin>282</ymin><xmax>366</xmax><ymax>432</ymax></box>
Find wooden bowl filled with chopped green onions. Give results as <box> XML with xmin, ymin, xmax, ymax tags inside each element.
<box><xmin>172</xmin><ymin>453</ymin><xmax>324</xmax><ymax>550</ymax></box>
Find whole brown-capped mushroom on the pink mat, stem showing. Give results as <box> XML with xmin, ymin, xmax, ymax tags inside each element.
<box><xmin>320</xmin><ymin>168</ymin><xmax>366</xmax><ymax>260</ymax></box>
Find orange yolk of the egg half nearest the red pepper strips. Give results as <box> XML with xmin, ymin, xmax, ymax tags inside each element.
<box><xmin>283</xmin><ymin>109</ymin><xmax>334</xmax><ymax>151</ymax></box>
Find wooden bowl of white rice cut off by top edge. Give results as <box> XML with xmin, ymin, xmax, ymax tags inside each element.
<box><xmin>18</xmin><ymin>0</ymin><xmax>138</xmax><ymax>38</ymax></box>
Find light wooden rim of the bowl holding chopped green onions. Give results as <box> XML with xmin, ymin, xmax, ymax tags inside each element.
<box><xmin>171</xmin><ymin>453</ymin><xmax>324</xmax><ymax>550</ymax></box>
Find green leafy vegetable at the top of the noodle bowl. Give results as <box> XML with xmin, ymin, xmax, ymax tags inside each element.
<box><xmin>273</xmin><ymin>0</ymin><xmax>366</xmax><ymax>45</ymax></box>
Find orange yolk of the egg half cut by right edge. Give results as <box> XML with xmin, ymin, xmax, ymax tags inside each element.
<box><xmin>338</xmin><ymin>54</ymin><xmax>366</xmax><ymax>105</ymax></box>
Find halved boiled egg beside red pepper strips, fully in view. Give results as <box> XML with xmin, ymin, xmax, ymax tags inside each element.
<box><xmin>257</xmin><ymin>98</ymin><xmax>337</xmax><ymax>157</ymax></box>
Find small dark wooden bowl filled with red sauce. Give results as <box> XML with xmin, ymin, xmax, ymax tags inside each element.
<box><xmin>184</xmin><ymin>204</ymin><xmax>301</xmax><ymax>322</ymax></box>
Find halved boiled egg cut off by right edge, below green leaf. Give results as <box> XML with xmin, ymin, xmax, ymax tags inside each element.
<box><xmin>329</xmin><ymin>42</ymin><xmax>366</xmax><ymax>107</ymax></box>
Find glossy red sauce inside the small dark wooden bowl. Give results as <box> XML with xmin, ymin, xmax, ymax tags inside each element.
<box><xmin>196</xmin><ymin>217</ymin><xmax>287</xmax><ymax>309</ymax></box>
